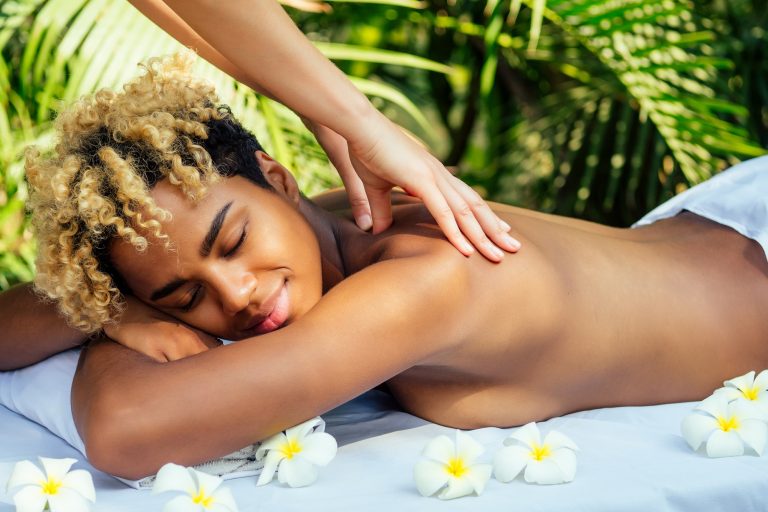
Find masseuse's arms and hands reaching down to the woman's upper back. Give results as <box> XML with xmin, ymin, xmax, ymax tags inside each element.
<box><xmin>131</xmin><ymin>0</ymin><xmax>520</xmax><ymax>261</ymax></box>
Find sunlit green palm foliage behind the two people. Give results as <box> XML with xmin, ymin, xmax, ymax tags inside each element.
<box><xmin>0</xmin><ymin>0</ymin><xmax>768</xmax><ymax>289</ymax></box>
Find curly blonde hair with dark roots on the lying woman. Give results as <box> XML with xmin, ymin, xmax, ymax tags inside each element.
<box><xmin>26</xmin><ymin>53</ymin><xmax>269</xmax><ymax>333</ymax></box>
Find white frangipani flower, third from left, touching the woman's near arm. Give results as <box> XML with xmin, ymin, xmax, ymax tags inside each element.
<box><xmin>256</xmin><ymin>417</ymin><xmax>338</xmax><ymax>487</ymax></box>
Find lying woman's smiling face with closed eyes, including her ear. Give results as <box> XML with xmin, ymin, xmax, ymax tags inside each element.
<box><xmin>110</xmin><ymin>154</ymin><xmax>322</xmax><ymax>340</ymax></box>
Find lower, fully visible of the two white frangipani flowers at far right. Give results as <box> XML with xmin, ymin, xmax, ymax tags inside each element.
<box><xmin>680</xmin><ymin>394</ymin><xmax>768</xmax><ymax>457</ymax></box>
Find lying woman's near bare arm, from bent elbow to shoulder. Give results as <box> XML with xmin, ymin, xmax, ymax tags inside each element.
<box><xmin>72</xmin><ymin>249</ymin><xmax>469</xmax><ymax>478</ymax></box>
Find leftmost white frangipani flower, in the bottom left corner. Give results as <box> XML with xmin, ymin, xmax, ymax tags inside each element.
<box><xmin>7</xmin><ymin>457</ymin><xmax>96</xmax><ymax>512</ymax></box>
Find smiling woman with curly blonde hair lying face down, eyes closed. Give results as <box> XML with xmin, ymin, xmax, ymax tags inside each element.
<box><xmin>12</xmin><ymin>58</ymin><xmax>768</xmax><ymax>478</ymax></box>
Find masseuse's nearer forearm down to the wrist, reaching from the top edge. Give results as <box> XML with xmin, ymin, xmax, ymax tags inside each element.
<box><xmin>159</xmin><ymin>0</ymin><xmax>377</xmax><ymax>141</ymax></box>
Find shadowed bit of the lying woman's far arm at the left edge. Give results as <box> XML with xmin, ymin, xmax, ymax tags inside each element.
<box><xmin>0</xmin><ymin>283</ymin><xmax>86</xmax><ymax>371</ymax></box>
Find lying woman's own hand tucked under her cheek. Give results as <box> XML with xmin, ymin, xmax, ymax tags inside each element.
<box><xmin>104</xmin><ymin>296</ymin><xmax>221</xmax><ymax>363</ymax></box>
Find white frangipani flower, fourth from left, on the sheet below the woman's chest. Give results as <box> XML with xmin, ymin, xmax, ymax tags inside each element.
<box><xmin>413</xmin><ymin>430</ymin><xmax>491</xmax><ymax>500</ymax></box>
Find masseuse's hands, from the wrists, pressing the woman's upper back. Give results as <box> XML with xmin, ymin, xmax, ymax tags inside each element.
<box><xmin>312</xmin><ymin>111</ymin><xmax>520</xmax><ymax>261</ymax></box>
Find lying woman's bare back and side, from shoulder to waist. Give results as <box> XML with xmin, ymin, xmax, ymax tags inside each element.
<box><xmin>338</xmin><ymin>200</ymin><xmax>768</xmax><ymax>428</ymax></box>
